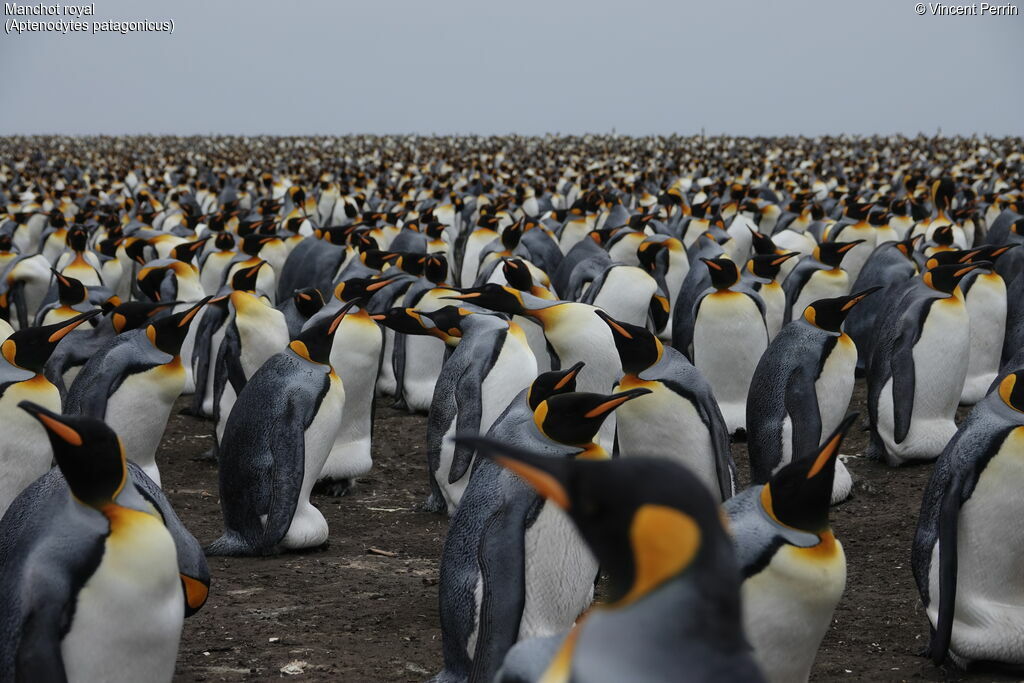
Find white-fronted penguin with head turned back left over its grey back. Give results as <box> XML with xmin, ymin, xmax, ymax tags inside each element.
<box><xmin>381</xmin><ymin>306</ymin><xmax>537</xmax><ymax>515</ymax></box>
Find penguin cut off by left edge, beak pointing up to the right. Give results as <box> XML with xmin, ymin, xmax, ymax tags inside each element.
<box><xmin>0</xmin><ymin>311</ymin><xmax>99</xmax><ymax>517</ymax></box>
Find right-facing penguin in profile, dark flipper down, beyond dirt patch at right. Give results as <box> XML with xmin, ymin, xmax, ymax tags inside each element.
<box><xmin>867</xmin><ymin>263</ymin><xmax>983</xmax><ymax>466</ymax></box>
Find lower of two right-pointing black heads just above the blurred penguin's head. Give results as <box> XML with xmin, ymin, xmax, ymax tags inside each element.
<box><xmin>534</xmin><ymin>389</ymin><xmax>650</xmax><ymax>448</ymax></box>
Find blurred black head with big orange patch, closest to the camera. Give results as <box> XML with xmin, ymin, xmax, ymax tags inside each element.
<box><xmin>456</xmin><ymin>435</ymin><xmax>739</xmax><ymax>606</ymax></box>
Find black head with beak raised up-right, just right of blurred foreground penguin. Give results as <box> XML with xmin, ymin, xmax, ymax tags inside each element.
<box><xmin>761</xmin><ymin>413</ymin><xmax>857</xmax><ymax>533</ymax></box>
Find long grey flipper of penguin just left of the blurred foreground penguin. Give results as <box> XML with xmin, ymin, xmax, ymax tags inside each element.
<box><xmin>470</xmin><ymin>497</ymin><xmax>536</xmax><ymax>681</ymax></box>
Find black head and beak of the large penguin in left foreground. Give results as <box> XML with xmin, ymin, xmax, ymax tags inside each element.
<box><xmin>18</xmin><ymin>400</ymin><xmax>128</xmax><ymax>509</ymax></box>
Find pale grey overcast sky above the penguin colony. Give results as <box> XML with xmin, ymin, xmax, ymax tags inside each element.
<box><xmin>0</xmin><ymin>0</ymin><xmax>1024</xmax><ymax>135</ymax></box>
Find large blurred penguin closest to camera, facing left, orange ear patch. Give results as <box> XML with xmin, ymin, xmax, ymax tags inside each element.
<box><xmin>473</xmin><ymin>439</ymin><xmax>764</xmax><ymax>683</ymax></box>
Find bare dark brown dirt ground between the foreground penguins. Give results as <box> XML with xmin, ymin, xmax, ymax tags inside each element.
<box><xmin>158</xmin><ymin>384</ymin><xmax>1015</xmax><ymax>681</ymax></box>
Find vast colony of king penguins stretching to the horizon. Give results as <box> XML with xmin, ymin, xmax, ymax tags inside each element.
<box><xmin>0</xmin><ymin>137</ymin><xmax>1024</xmax><ymax>682</ymax></box>
